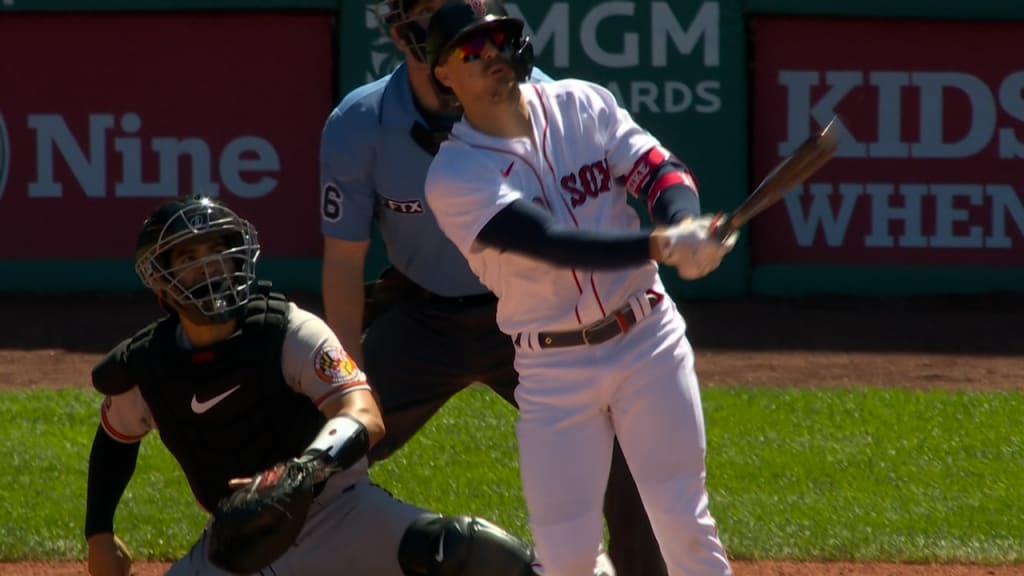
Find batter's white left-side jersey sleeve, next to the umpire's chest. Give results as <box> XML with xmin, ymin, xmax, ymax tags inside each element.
<box><xmin>424</xmin><ymin>146</ymin><xmax>523</xmax><ymax>254</ymax></box>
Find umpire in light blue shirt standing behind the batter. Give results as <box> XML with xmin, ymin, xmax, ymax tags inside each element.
<box><xmin>321</xmin><ymin>0</ymin><xmax>667</xmax><ymax>576</ymax></box>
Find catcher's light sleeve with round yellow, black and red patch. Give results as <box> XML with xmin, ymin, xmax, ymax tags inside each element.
<box><xmin>281</xmin><ymin>302</ymin><xmax>370</xmax><ymax>408</ymax></box>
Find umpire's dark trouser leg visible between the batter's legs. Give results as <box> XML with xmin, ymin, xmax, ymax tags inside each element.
<box><xmin>604</xmin><ymin>440</ymin><xmax>669</xmax><ymax>576</ymax></box>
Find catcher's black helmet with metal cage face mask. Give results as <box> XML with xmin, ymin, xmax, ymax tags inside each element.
<box><xmin>135</xmin><ymin>196</ymin><xmax>259</xmax><ymax>324</ymax></box>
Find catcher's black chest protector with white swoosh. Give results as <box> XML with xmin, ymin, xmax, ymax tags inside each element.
<box><xmin>126</xmin><ymin>288</ymin><xmax>325</xmax><ymax>509</ymax></box>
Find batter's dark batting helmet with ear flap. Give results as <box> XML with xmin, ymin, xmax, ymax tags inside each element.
<box><xmin>427</xmin><ymin>0</ymin><xmax>534</xmax><ymax>97</ymax></box>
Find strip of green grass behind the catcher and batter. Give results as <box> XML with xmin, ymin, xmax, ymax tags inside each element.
<box><xmin>0</xmin><ymin>388</ymin><xmax>1024</xmax><ymax>564</ymax></box>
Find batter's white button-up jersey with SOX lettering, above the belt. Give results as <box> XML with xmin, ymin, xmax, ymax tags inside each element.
<box><xmin>426</xmin><ymin>80</ymin><xmax>664</xmax><ymax>334</ymax></box>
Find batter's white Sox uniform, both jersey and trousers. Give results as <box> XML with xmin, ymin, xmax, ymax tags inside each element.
<box><xmin>426</xmin><ymin>80</ymin><xmax>731</xmax><ymax>576</ymax></box>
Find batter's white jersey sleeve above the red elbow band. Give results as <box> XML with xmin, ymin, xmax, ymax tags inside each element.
<box><xmin>573</xmin><ymin>80</ymin><xmax>660</xmax><ymax>176</ymax></box>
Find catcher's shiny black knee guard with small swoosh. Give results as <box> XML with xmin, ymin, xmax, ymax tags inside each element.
<box><xmin>398</xmin><ymin>515</ymin><xmax>536</xmax><ymax>576</ymax></box>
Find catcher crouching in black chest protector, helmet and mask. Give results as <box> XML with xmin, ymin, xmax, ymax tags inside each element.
<box><xmin>85</xmin><ymin>197</ymin><xmax>569</xmax><ymax>576</ymax></box>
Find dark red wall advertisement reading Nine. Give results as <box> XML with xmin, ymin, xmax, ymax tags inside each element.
<box><xmin>0</xmin><ymin>12</ymin><xmax>333</xmax><ymax>258</ymax></box>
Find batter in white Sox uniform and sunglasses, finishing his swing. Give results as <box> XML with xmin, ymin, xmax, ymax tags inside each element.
<box><xmin>426</xmin><ymin>0</ymin><xmax>735</xmax><ymax>576</ymax></box>
